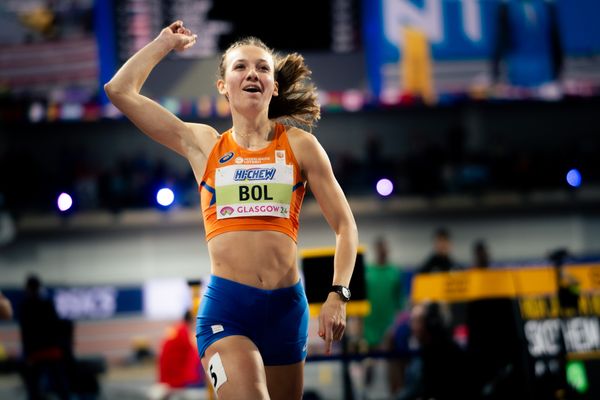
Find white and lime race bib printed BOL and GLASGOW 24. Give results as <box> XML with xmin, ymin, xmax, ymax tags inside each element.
<box><xmin>215</xmin><ymin>163</ymin><xmax>294</xmax><ymax>219</ymax></box>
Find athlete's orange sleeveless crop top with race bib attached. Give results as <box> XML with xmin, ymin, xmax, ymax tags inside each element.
<box><xmin>198</xmin><ymin>123</ymin><xmax>306</xmax><ymax>241</ymax></box>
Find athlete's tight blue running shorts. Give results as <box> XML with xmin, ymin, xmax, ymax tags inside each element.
<box><xmin>196</xmin><ymin>275</ymin><xmax>309</xmax><ymax>365</ymax></box>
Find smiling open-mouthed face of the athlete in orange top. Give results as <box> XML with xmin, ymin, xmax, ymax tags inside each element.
<box><xmin>217</xmin><ymin>46</ymin><xmax>278</xmax><ymax>115</ymax></box>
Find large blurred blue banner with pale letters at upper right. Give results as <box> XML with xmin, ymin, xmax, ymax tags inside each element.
<box><xmin>363</xmin><ymin>0</ymin><xmax>600</xmax><ymax>101</ymax></box>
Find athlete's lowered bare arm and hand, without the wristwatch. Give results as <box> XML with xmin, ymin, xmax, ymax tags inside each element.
<box><xmin>294</xmin><ymin>132</ymin><xmax>358</xmax><ymax>354</ymax></box>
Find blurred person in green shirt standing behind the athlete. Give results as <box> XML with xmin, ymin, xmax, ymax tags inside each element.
<box><xmin>364</xmin><ymin>237</ymin><xmax>403</xmax><ymax>396</ymax></box>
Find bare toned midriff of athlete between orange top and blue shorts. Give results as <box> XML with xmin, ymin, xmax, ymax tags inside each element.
<box><xmin>208</xmin><ymin>231</ymin><xmax>300</xmax><ymax>290</ymax></box>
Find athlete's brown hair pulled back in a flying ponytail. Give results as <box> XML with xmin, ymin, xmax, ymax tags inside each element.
<box><xmin>218</xmin><ymin>36</ymin><xmax>321</xmax><ymax>129</ymax></box>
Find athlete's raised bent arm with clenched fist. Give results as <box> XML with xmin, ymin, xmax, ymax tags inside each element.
<box><xmin>104</xmin><ymin>21</ymin><xmax>217</xmax><ymax>162</ymax></box>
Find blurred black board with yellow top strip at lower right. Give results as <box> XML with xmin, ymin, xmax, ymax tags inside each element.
<box><xmin>411</xmin><ymin>264</ymin><xmax>600</xmax><ymax>398</ymax></box>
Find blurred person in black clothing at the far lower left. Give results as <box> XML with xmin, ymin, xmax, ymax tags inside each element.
<box><xmin>18</xmin><ymin>275</ymin><xmax>71</xmax><ymax>400</ymax></box>
